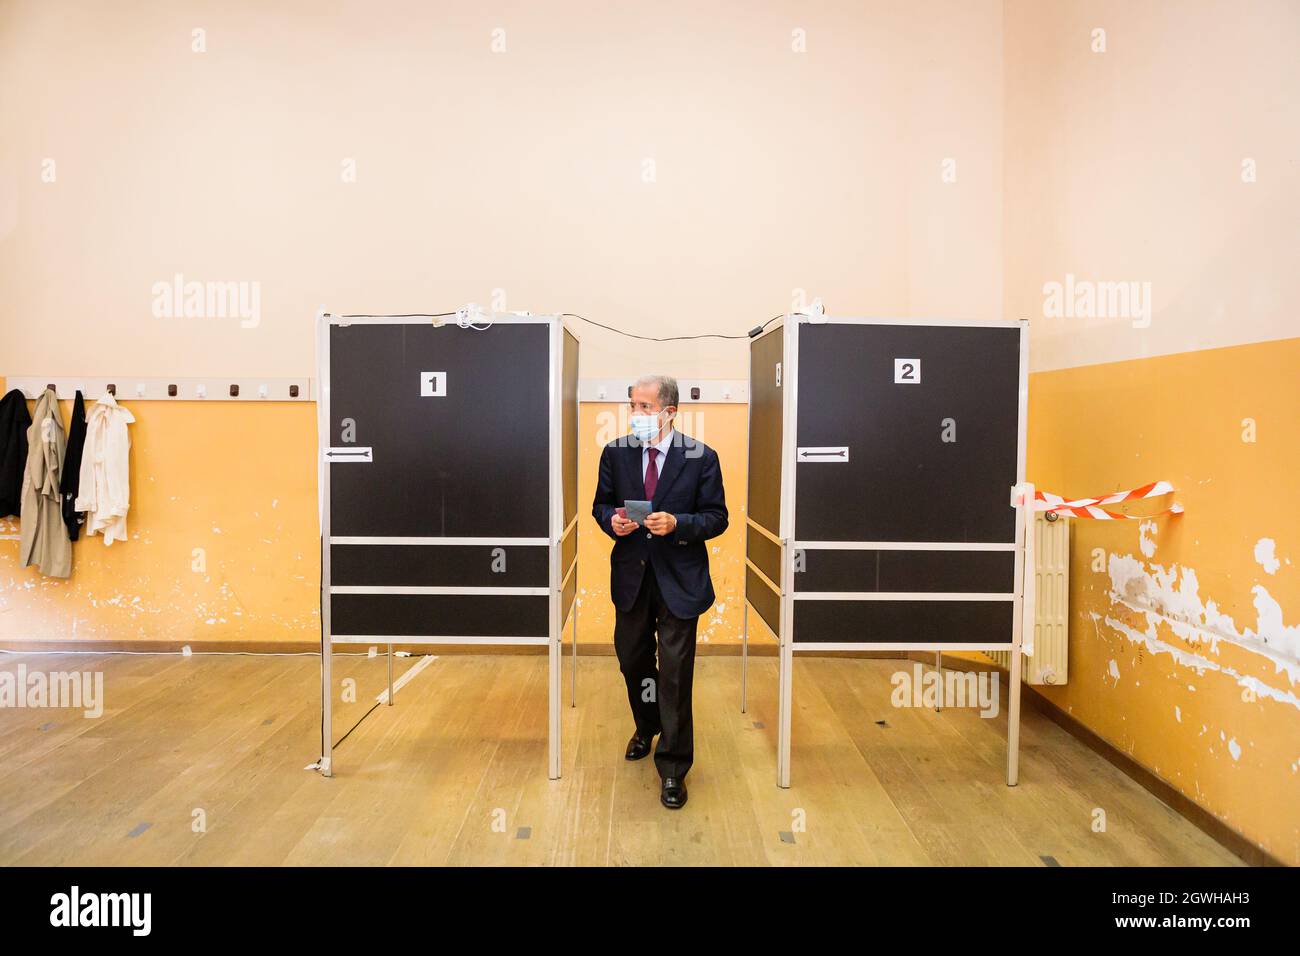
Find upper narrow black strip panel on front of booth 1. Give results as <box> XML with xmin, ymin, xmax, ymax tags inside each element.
<box><xmin>330</xmin><ymin>544</ymin><xmax>550</xmax><ymax>588</ymax></box>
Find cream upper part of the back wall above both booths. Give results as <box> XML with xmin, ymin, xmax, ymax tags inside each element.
<box><xmin>0</xmin><ymin>0</ymin><xmax>1002</xmax><ymax>378</ymax></box>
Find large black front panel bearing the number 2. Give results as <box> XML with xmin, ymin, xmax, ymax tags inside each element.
<box><xmin>794</xmin><ymin>323</ymin><xmax>1021</xmax><ymax>542</ymax></box>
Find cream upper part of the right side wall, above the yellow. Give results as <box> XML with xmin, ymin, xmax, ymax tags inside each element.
<box><xmin>1004</xmin><ymin>0</ymin><xmax>1300</xmax><ymax>369</ymax></box>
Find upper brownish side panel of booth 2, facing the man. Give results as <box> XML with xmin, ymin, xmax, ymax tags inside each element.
<box><xmin>748</xmin><ymin>329</ymin><xmax>785</xmax><ymax>538</ymax></box>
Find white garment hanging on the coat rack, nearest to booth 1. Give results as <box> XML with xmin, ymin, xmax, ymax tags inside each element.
<box><xmin>74</xmin><ymin>392</ymin><xmax>135</xmax><ymax>545</ymax></box>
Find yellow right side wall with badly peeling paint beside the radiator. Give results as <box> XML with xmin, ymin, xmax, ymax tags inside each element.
<box><xmin>1028</xmin><ymin>338</ymin><xmax>1300</xmax><ymax>864</ymax></box>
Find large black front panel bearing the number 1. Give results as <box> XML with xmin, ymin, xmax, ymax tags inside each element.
<box><xmin>329</xmin><ymin>323</ymin><xmax>550</xmax><ymax>538</ymax></box>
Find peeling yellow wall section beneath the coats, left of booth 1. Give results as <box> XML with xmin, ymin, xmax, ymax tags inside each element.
<box><xmin>0</xmin><ymin>401</ymin><xmax>320</xmax><ymax>643</ymax></box>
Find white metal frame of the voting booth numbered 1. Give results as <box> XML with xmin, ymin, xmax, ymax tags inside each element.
<box><xmin>316</xmin><ymin>312</ymin><xmax>579</xmax><ymax>779</ymax></box>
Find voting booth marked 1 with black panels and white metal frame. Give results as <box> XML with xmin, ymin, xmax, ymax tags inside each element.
<box><xmin>317</xmin><ymin>310</ymin><xmax>579</xmax><ymax>779</ymax></box>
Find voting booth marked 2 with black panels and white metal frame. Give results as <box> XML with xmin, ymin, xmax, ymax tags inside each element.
<box><xmin>745</xmin><ymin>313</ymin><xmax>1032</xmax><ymax>787</ymax></box>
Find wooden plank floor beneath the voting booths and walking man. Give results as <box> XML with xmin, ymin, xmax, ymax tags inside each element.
<box><xmin>0</xmin><ymin>654</ymin><xmax>1240</xmax><ymax>866</ymax></box>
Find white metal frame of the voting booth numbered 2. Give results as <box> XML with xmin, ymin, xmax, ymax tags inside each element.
<box><xmin>741</xmin><ymin>312</ymin><xmax>1034</xmax><ymax>787</ymax></box>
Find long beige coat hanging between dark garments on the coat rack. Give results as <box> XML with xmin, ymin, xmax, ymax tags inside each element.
<box><xmin>20</xmin><ymin>389</ymin><xmax>73</xmax><ymax>578</ymax></box>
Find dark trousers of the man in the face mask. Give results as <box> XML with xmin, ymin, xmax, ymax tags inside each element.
<box><xmin>614</xmin><ymin>567</ymin><xmax>699</xmax><ymax>778</ymax></box>
